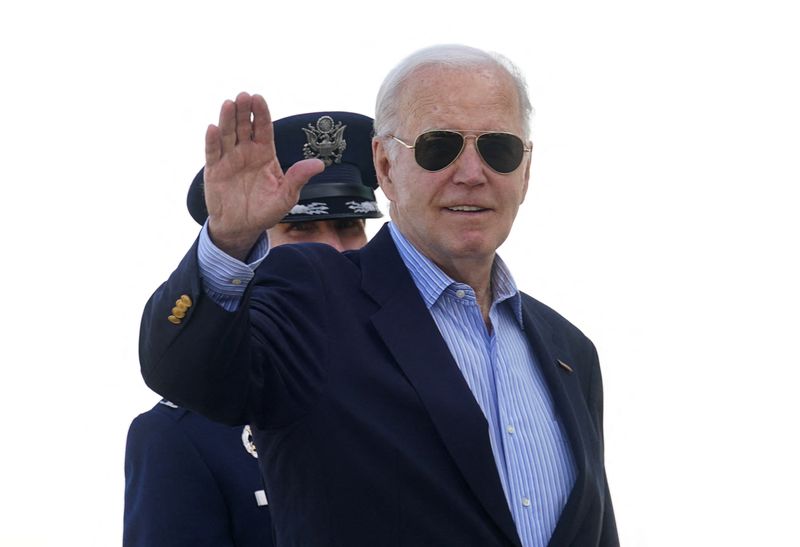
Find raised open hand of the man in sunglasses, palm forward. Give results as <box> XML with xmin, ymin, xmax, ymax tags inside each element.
<box><xmin>205</xmin><ymin>93</ymin><xmax>325</xmax><ymax>260</ymax></box>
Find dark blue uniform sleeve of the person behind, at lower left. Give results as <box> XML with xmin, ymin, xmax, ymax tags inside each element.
<box><xmin>123</xmin><ymin>413</ymin><xmax>233</xmax><ymax>547</ymax></box>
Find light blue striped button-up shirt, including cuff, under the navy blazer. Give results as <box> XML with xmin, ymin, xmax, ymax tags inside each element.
<box><xmin>198</xmin><ymin>223</ymin><xmax>576</xmax><ymax>547</ymax></box>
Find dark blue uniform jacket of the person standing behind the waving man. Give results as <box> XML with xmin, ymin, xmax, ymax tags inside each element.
<box><xmin>122</xmin><ymin>403</ymin><xmax>273</xmax><ymax>547</ymax></box>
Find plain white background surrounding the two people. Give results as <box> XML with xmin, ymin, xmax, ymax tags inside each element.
<box><xmin>0</xmin><ymin>0</ymin><xmax>800</xmax><ymax>547</ymax></box>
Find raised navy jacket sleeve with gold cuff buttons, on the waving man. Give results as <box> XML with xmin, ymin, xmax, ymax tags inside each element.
<box><xmin>139</xmin><ymin>243</ymin><xmax>338</xmax><ymax>427</ymax></box>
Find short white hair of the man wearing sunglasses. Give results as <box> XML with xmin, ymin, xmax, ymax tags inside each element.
<box><xmin>375</xmin><ymin>44</ymin><xmax>533</xmax><ymax>140</ymax></box>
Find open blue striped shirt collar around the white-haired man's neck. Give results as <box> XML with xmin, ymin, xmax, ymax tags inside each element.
<box><xmin>389</xmin><ymin>222</ymin><xmax>522</xmax><ymax>326</ymax></box>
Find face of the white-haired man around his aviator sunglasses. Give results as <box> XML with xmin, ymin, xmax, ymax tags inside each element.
<box><xmin>373</xmin><ymin>67</ymin><xmax>530</xmax><ymax>272</ymax></box>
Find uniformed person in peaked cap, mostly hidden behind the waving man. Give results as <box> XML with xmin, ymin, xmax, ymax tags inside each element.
<box><xmin>123</xmin><ymin>112</ymin><xmax>381</xmax><ymax>547</ymax></box>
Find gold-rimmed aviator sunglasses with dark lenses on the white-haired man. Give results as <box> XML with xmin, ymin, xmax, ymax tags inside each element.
<box><xmin>389</xmin><ymin>129</ymin><xmax>531</xmax><ymax>175</ymax></box>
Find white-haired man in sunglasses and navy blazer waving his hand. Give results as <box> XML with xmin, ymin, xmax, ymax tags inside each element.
<box><xmin>140</xmin><ymin>46</ymin><xmax>618</xmax><ymax>547</ymax></box>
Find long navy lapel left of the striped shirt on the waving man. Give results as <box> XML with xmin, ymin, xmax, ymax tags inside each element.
<box><xmin>360</xmin><ymin>226</ymin><xmax>520</xmax><ymax>545</ymax></box>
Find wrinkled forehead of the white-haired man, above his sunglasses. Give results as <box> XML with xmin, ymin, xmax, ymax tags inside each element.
<box><xmin>399</xmin><ymin>66</ymin><xmax>523</xmax><ymax>136</ymax></box>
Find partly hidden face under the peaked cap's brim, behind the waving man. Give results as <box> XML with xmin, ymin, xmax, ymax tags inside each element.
<box><xmin>268</xmin><ymin>218</ymin><xmax>367</xmax><ymax>252</ymax></box>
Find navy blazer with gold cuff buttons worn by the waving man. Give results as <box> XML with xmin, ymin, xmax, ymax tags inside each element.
<box><xmin>140</xmin><ymin>226</ymin><xmax>618</xmax><ymax>547</ymax></box>
